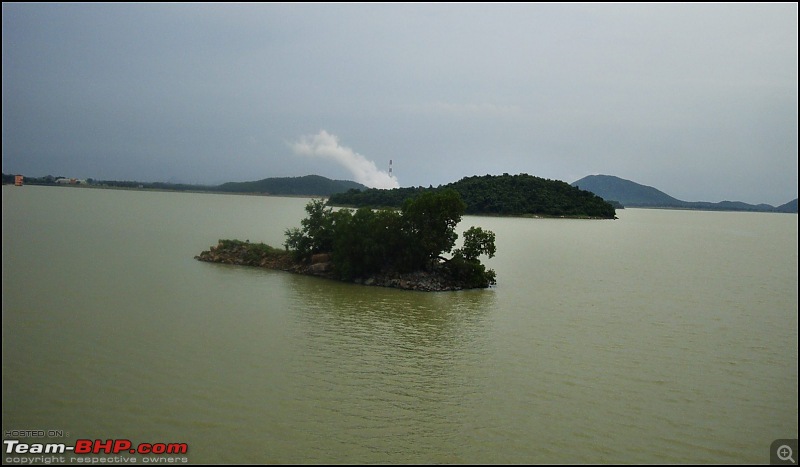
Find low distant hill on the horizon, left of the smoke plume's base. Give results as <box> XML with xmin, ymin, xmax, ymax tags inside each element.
<box><xmin>214</xmin><ymin>175</ymin><xmax>367</xmax><ymax>196</ymax></box>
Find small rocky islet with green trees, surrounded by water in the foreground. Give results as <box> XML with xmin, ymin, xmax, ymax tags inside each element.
<box><xmin>195</xmin><ymin>190</ymin><xmax>496</xmax><ymax>292</ymax></box>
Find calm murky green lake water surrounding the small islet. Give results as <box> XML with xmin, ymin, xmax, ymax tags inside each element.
<box><xmin>2</xmin><ymin>186</ymin><xmax>798</xmax><ymax>464</ymax></box>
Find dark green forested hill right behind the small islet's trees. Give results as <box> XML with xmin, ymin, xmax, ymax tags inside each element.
<box><xmin>328</xmin><ymin>174</ymin><xmax>616</xmax><ymax>219</ymax></box>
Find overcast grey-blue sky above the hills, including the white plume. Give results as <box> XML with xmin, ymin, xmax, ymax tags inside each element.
<box><xmin>2</xmin><ymin>3</ymin><xmax>798</xmax><ymax>205</ymax></box>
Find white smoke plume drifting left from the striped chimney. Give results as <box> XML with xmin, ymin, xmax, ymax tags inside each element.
<box><xmin>292</xmin><ymin>130</ymin><xmax>400</xmax><ymax>188</ymax></box>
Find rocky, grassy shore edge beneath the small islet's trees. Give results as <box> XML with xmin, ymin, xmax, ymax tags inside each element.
<box><xmin>195</xmin><ymin>240</ymin><xmax>488</xmax><ymax>292</ymax></box>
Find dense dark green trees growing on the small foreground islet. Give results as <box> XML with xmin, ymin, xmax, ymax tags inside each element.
<box><xmin>284</xmin><ymin>190</ymin><xmax>495</xmax><ymax>288</ymax></box>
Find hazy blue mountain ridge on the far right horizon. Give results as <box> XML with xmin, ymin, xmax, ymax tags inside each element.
<box><xmin>571</xmin><ymin>175</ymin><xmax>797</xmax><ymax>213</ymax></box>
